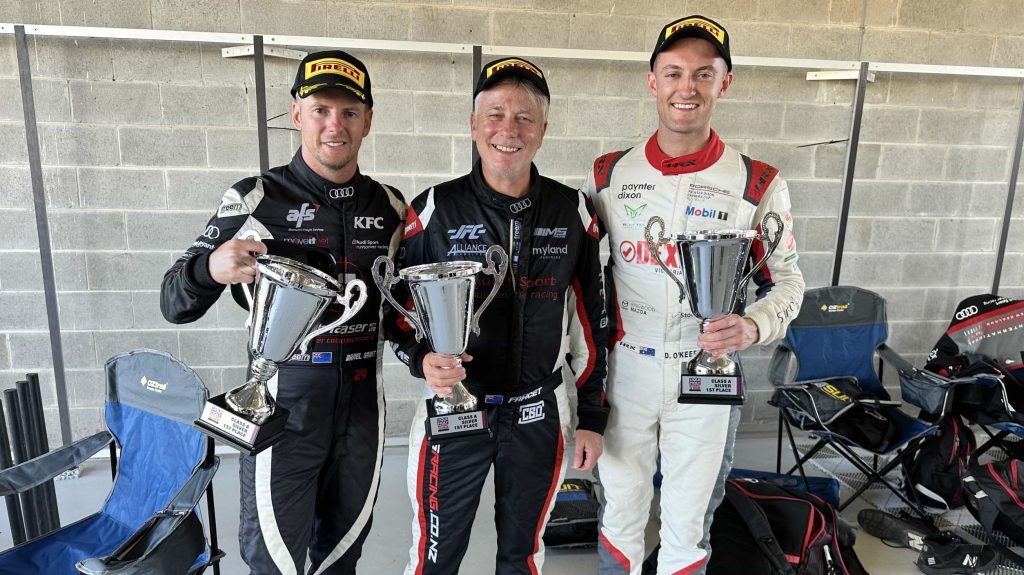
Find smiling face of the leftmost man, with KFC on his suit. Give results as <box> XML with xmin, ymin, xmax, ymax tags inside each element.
<box><xmin>292</xmin><ymin>89</ymin><xmax>374</xmax><ymax>183</ymax></box>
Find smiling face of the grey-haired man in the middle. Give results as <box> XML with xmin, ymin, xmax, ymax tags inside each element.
<box><xmin>469</xmin><ymin>84</ymin><xmax>548</xmax><ymax>195</ymax></box>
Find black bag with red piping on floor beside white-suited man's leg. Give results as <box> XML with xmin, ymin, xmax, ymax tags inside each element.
<box><xmin>708</xmin><ymin>479</ymin><xmax>867</xmax><ymax>575</ymax></box>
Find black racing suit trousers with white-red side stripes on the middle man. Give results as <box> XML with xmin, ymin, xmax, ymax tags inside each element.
<box><xmin>406</xmin><ymin>373</ymin><xmax>570</xmax><ymax>575</ymax></box>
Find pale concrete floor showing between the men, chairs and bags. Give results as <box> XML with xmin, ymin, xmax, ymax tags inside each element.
<box><xmin>0</xmin><ymin>436</ymin><xmax>919</xmax><ymax>575</ymax></box>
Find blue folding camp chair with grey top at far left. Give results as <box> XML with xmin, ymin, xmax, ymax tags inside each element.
<box><xmin>0</xmin><ymin>350</ymin><xmax>223</xmax><ymax>575</ymax></box>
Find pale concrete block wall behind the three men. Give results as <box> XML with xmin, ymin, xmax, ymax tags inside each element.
<box><xmin>0</xmin><ymin>0</ymin><xmax>1024</xmax><ymax>438</ymax></box>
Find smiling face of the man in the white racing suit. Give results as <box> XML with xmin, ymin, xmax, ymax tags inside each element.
<box><xmin>647</xmin><ymin>38</ymin><xmax>732</xmax><ymax>152</ymax></box>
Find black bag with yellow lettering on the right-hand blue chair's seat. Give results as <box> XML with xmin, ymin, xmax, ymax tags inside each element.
<box><xmin>768</xmin><ymin>378</ymin><xmax>899</xmax><ymax>452</ymax></box>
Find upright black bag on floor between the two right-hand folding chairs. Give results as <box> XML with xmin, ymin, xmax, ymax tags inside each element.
<box><xmin>903</xmin><ymin>415</ymin><xmax>978</xmax><ymax>511</ymax></box>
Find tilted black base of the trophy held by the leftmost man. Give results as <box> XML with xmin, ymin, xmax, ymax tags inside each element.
<box><xmin>196</xmin><ymin>394</ymin><xmax>288</xmax><ymax>455</ymax></box>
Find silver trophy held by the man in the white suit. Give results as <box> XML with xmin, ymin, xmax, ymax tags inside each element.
<box><xmin>644</xmin><ymin>212</ymin><xmax>783</xmax><ymax>404</ymax></box>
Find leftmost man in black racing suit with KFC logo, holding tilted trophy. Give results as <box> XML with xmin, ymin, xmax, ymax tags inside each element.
<box><xmin>161</xmin><ymin>50</ymin><xmax>406</xmax><ymax>575</ymax></box>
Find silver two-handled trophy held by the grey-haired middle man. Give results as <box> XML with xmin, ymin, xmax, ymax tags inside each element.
<box><xmin>373</xmin><ymin>246</ymin><xmax>508</xmax><ymax>414</ymax></box>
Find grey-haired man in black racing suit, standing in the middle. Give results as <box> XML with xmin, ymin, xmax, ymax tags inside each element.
<box><xmin>387</xmin><ymin>54</ymin><xmax>608</xmax><ymax>575</ymax></box>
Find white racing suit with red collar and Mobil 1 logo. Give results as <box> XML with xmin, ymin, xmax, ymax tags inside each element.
<box><xmin>585</xmin><ymin>132</ymin><xmax>804</xmax><ymax>575</ymax></box>
